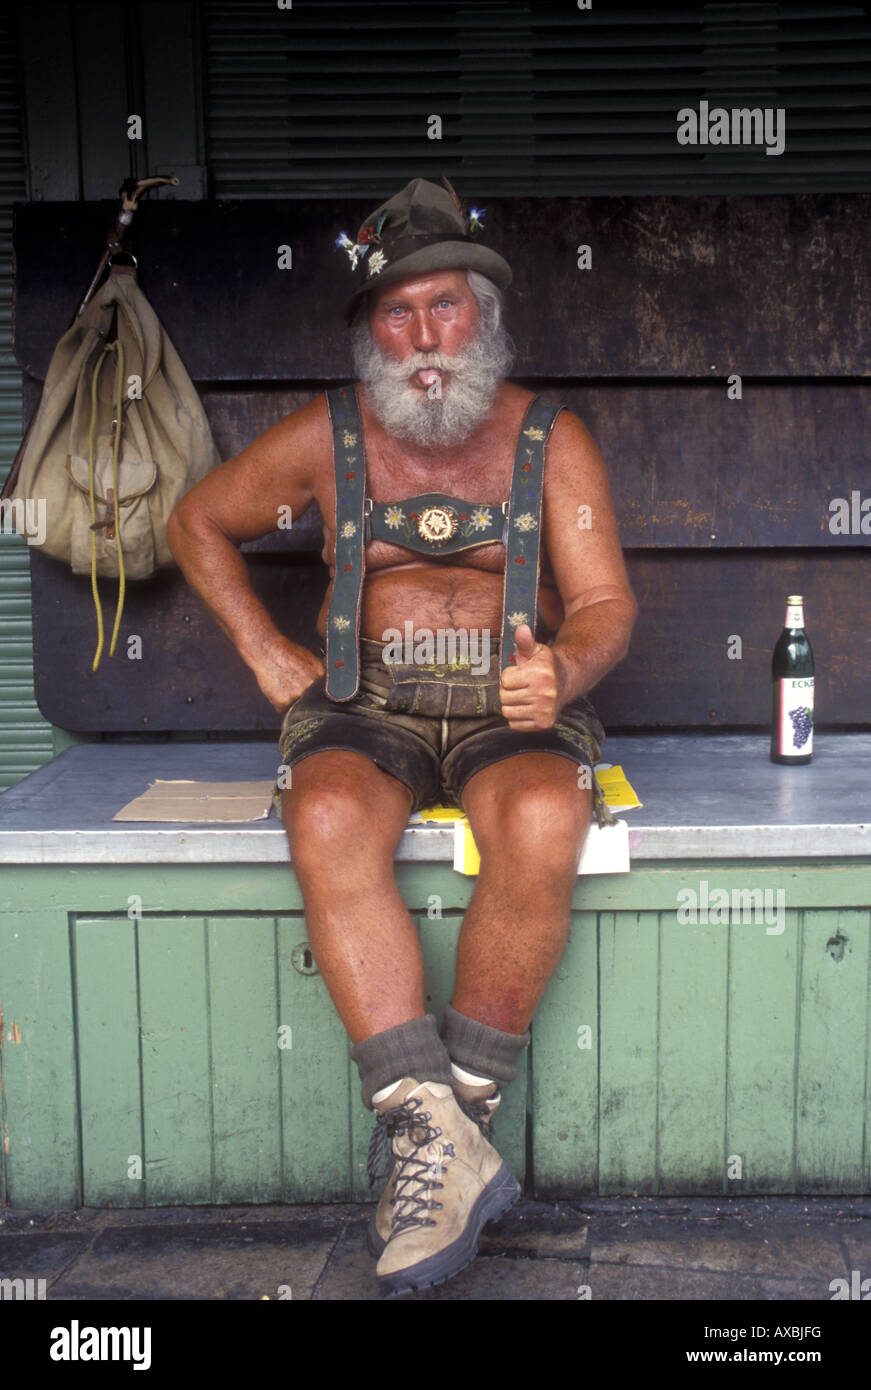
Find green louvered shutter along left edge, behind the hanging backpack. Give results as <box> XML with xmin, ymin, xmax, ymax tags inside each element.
<box><xmin>0</xmin><ymin>8</ymin><xmax>54</xmax><ymax>791</ymax></box>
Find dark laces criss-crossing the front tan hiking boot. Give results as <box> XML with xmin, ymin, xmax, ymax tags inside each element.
<box><xmin>367</xmin><ymin>1095</ymin><xmax>456</xmax><ymax>1238</ymax></box>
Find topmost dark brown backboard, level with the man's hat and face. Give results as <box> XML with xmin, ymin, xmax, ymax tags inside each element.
<box><xmin>14</xmin><ymin>189</ymin><xmax>871</xmax><ymax>382</ymax></box>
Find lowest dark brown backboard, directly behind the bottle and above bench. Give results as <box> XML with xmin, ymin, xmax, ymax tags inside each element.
<box><xmin>32</xmin><ymin>550</ymin><xmax>871</xmax><ymax>733</ymax></box>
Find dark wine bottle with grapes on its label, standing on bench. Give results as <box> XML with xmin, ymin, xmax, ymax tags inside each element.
<box><xmin>771</xmin><ymin>594</ymin><xmax>814</xmax><ymax>763</ymax></box>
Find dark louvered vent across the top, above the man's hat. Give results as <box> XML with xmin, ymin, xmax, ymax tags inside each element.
<box><xmin>204</xmin><ymin>0</ymin><xmax>871</xmax><ymax>197</ymax></box>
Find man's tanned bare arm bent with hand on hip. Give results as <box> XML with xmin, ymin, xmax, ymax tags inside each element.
<box><xmin>167</xmin><ymin>396</ymin><xmax>332</xmax><ymax>713</ymax></box>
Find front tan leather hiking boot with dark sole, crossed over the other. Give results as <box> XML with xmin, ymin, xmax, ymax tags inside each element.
<box><xmin>368</xmin><ymin>1077</ymin><xmax>521</xmax><ymax>1294</ymax></box>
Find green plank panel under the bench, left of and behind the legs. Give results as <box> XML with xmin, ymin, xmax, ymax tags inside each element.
<box><xmin>68</xmin><ymin>913</ymin><xmax>526</xmax><ymax>1207</ymax></box>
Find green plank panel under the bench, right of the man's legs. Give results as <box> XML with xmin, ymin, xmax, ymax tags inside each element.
<box><xmin>532</xmin><ymin>895</ymin><xmax>871</xmax><ymax>1197</ymax></box>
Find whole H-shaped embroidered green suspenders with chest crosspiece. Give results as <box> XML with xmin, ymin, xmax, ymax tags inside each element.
<box><xmin>325</xmin><ymin>385</ymin><xmax>563</xmax><ymax>702</ymax></box>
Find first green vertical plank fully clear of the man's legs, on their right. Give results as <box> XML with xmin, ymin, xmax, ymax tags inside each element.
<box><xmin>599</xmin><ymin>912</ymin><xmax>658</xmax><ymax>1195</ymax></box>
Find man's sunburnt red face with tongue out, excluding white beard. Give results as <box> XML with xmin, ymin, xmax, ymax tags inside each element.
<box><xmin>370</xmin><ymin>270</ymin><xmax>481</xmax><ymax>391</ymax></box>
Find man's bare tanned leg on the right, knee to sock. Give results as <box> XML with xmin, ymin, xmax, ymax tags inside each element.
<box><xmin>453</xmin><ymin>753</ymin><xmax>593</xmax><ymax>1034</ymax></box>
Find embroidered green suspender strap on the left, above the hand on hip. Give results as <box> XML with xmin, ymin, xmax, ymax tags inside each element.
<box><xmin>325</xmin><ymin>385</ymin><xmax>365</xmax><ymax>701</ymax></box>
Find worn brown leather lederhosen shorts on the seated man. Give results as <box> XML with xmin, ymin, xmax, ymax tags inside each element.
<box><xmin>272</xmin><ymin>638</ymin><xmax>614</xmax><ymax>826</ymax></box>
